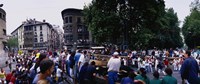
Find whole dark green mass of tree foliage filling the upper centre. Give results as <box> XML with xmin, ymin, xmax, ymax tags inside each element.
<box><xmin>83</xmin><ymin>0</ymin><xmax>183</xmax><ymax>49</ymax></box>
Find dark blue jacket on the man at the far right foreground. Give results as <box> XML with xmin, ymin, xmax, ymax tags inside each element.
<box><xmin>180</xmin><ymin>57</ymin><xmax>199</xmax><ymax>84</ymax></box>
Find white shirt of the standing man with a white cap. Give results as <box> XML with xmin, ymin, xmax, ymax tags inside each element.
<box><xmin>107</xmin><ymin>57</ymin><xmax>121</xmax><ymax>72</ymax></box>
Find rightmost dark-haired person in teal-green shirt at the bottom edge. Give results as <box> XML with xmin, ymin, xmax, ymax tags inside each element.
<box><xmin>162</xmin><ymin>67</ymin><xmax>177</xmax><ymax>84</ymax></box>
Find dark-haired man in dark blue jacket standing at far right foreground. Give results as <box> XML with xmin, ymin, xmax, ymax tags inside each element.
<box><xmin>180</xmin><ymin>50</ymin><xmax>200</xmax><ymax>84</ymax></box>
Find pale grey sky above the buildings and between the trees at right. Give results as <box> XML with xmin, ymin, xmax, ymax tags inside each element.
<box><xmin>0</xmin><ymin>0</ymin><xmax>193</xmax><ymax>35</ymax></box>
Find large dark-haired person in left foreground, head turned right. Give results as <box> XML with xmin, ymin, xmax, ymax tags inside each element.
<box><xmin>32</xmin><ymin>59</ymin><xmax>54</xmax><ymax>84</ymax></box>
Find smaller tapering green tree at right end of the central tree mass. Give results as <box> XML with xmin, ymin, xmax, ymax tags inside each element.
<box><xmin>155</xmin><ymin>8</ymin><xmax>183</xmax><ymax>48</ymax></box>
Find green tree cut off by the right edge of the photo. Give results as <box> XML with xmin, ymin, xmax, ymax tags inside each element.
<box><xmin>182</xmin><ymin>0</ymin><xmax>200</xmax><ymax>48</ymax></box>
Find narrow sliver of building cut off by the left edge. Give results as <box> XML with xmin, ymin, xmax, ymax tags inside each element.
<box><xmin>0</xmin><ymin>7</ymin><xmax>7</xmax><ymax>52</ymax></box>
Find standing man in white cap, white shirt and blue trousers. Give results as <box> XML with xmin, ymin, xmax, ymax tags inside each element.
<box><xmin>107</xmin><ymin>52</ymin><xmax>121</xmax><ymax>84</ymax></box>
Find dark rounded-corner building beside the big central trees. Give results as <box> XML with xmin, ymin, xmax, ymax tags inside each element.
<box><xmin>61</xmin><ymin>8</ymin><xmax>90</xmax><ymax>49</ymax></box>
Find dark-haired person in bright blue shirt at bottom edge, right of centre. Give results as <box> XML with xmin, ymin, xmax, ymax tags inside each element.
<box><xmin>120</xmin><ymin>72</ymin><xmax>136</xmax><ymax>84</ymax></box>
